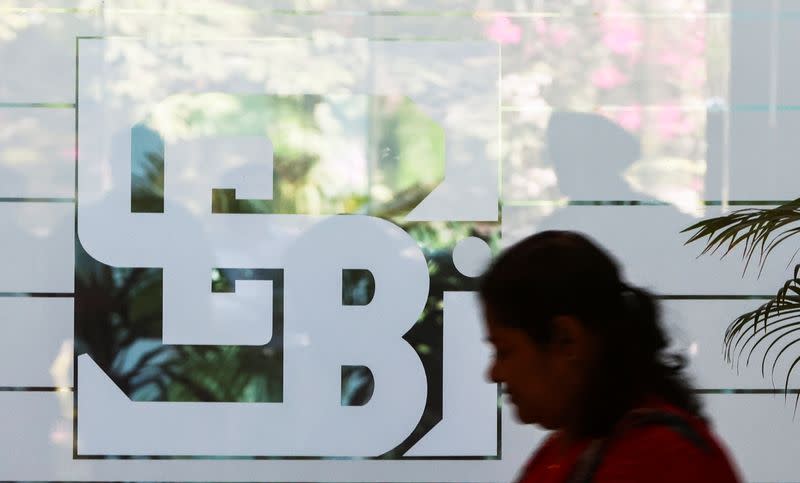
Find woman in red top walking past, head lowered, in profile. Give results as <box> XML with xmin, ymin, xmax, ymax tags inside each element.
<box><xmin>480</xmin><ymin>231</ymin><xmax>739</xmax><ymax>483</ymax></box>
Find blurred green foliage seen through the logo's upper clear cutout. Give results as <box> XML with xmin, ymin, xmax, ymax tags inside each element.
<box><xmin>131</xmin><ymin>93</ymin><xmax>444</xmax><ymax>216</ymax></box>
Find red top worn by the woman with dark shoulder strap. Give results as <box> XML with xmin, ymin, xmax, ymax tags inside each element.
<box><xmin>520</xmin><ymin>405</ymin><xmax>741</xmax><ymax>483</ymax></box>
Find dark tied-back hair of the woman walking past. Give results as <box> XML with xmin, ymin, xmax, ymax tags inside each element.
<box><xmin>479</xmin><ymin>231</ymin><xmax>701</xmax><ymax>437</ymax></box>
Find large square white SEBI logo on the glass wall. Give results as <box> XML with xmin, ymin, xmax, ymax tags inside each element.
<box><xmin>76</xmin><ymin>39</ymin><xmax>498</xmax><ymax>458</ymax></box>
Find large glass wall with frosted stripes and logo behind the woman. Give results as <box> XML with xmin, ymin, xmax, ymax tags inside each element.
<box><xmin>7</xmin><ymin>0</ymin><xmax>800</xmax><ymax>482</ymax></box>
